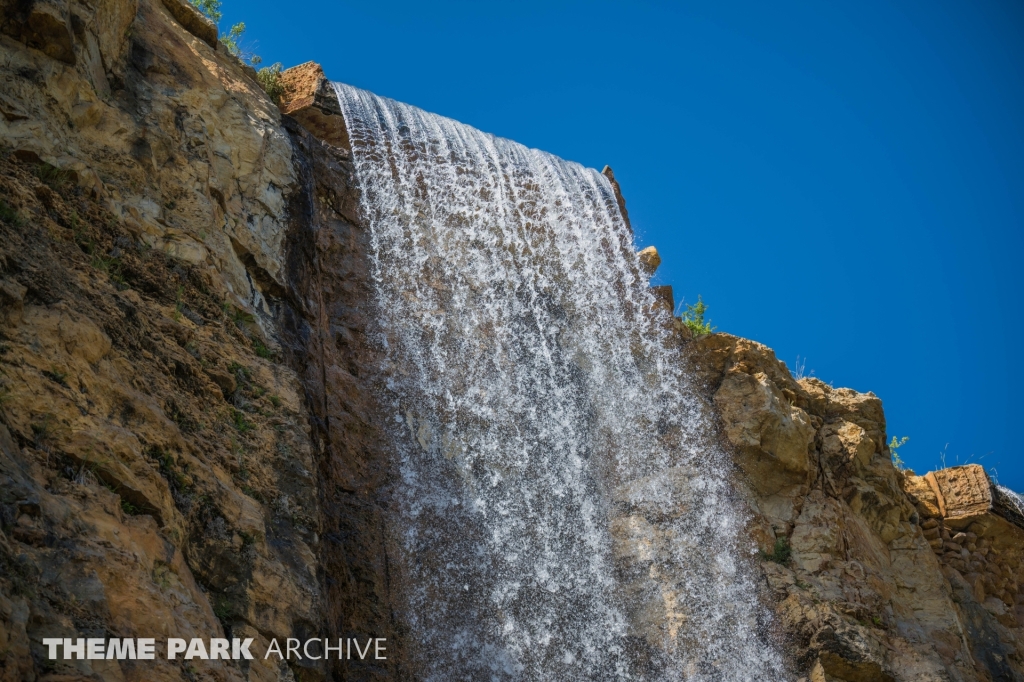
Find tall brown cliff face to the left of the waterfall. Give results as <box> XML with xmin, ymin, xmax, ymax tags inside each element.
<box><xmin>0</xmin><ymin>0</ymin><xmax>397</xmax><ymax>682</ymax></box>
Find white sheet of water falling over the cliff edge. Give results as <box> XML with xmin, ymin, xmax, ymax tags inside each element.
<box><xmin>335</xmin><ymin>84</ymin><xmax>783</xmax><ymax>682</ymax></box>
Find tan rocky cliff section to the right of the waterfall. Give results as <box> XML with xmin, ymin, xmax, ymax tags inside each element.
<box><xmin>679</xmin><ymin>334</ymin><xmax>1024</xmax><ymax>682</ymax></box>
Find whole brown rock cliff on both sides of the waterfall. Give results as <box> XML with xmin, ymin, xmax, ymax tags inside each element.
<box><xmin>0</xmin><ymin>0</ymin><xmax>1024</xmax><ymax>682</ymax></box>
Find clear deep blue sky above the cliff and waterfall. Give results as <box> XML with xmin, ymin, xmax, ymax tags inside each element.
<box><xmin>221</xmin><ymin>0</ymin><xmax>1024</xmax><ymax>491</ymax></box>
